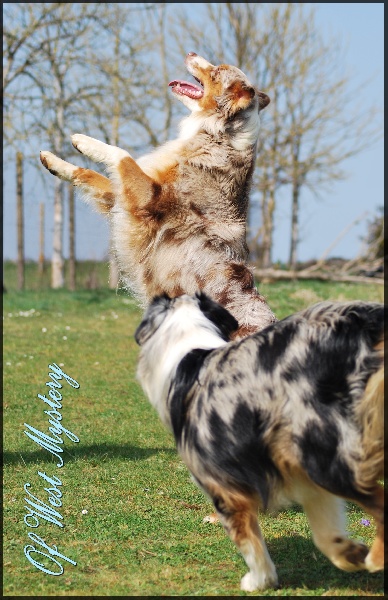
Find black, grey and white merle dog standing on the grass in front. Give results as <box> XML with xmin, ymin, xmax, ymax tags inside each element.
<box><xmin>136</xmin><ymin>294</ymin><xmax>384</xmax><ymax>591</ymax></box>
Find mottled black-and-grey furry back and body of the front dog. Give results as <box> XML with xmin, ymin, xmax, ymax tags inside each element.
<box><xmin>172</xmin><ymin>303</ymin><xmax>383</xmax><ymax>505</ymax></box>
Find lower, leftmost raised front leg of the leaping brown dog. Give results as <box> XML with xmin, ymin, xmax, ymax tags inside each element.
<box><xmin>40</xmin><ymin>151</ymin><xmax>114</xmax><ymax>213</ymax></box>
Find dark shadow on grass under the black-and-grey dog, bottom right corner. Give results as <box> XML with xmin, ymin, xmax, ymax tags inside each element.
<box><xmin>268</xmin><ymin>535</ymin><xmax>384</xmax><ymax>595</ymax></box>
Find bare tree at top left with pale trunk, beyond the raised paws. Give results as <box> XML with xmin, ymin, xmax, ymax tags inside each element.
<box><xmin>4</xmin><ymin>3</ymin><xmax>106</xmax><ymax>287</ymax></box>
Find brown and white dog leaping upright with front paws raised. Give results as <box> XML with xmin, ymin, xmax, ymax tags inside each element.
<box><xmin>40</xmin><ymin>52</ymin><xmax>276</xmax><ymax>337</ymax></box>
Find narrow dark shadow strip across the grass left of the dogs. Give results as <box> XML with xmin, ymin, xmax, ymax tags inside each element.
<box><xmin>3</xmin><ymin>443</ymin><xmax>176</xmax><ymax>465</ymax></box>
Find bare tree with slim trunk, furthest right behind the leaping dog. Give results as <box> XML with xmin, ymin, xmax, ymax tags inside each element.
<box><xmin>281</xmin><ymin>5</ymin><xmax>381</xmax><ymax>268</ymax></box>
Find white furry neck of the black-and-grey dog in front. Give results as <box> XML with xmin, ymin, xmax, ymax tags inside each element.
<box><xmin>137</xmin><ymin>311</ymin><xmax>226</xmax><ymax>430</ymax></box>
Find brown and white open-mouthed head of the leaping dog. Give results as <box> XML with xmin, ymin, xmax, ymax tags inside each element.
<box><xmin>169</xmin><ymin>52</ymin><xmax>270</xmax><ymax>118</ymax></box>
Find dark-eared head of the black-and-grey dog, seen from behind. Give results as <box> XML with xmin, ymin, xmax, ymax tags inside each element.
<box><xmin>135</xmin><ymin>292</ymin><xmax>238</xmax><ymax>347</ymax></box>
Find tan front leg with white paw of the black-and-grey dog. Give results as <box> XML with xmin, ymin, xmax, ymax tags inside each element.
<box><xmin>205</xmin><ymin>485</ymin><xmax>278</xmax><ymax>592</ymax></box>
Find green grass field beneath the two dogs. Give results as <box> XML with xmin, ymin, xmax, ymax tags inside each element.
<box><xmin>3</xmin><ymin>273</ymin><xmax>383</xmax><ymax>596</ymax></box>
